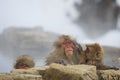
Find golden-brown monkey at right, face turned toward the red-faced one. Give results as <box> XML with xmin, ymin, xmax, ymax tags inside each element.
<box><xmin>85</xmin><ymin>43</ymin><xmax>118</xmax><ymax>70</ymax></box>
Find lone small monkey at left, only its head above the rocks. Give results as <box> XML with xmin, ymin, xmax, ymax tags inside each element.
<box><xmin>14</xmin><ymin>55</ymin><xmax>35</xmax><ymax>69</ymax></box>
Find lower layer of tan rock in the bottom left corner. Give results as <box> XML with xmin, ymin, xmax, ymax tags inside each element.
<box><xmin>0</xmin><ymin>73</ymin><xmax>42</xmax><ymax>80</ymax></box>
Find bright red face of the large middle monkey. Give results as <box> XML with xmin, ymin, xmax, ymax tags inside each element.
<box><xmin>62</xmin><ymin>41</ymin><xmax>73</xmax><ymax>53</ymax></box>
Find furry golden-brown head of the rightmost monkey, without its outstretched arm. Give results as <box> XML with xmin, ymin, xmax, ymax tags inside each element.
<box><xmin>86</xmin><ymin>43</ymin><xmax>104</xmax><ymax>65</ymax></box>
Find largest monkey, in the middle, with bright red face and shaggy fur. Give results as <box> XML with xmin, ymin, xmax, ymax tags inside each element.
<box><xmin>46</xmin><ymin>35</ymin><xmax>85</xmax><ymax>65</ymax></box>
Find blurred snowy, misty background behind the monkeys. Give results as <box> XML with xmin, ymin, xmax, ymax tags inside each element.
<box><xmin>0</xmin><ymin>0</ymin><xmax>120</xmax><ymax>72</ymax></box>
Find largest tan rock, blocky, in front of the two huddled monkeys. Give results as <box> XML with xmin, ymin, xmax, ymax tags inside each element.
<box><xmin>44</xmin><ymin>64</ymin><xmax>98</xmax><ymax>80</ymax></box>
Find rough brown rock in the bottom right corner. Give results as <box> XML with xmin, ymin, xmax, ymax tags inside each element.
<box><xmin>97</xmin><ymin>70</ymin><xmax>120</xmax><ymax>80</ymax></box>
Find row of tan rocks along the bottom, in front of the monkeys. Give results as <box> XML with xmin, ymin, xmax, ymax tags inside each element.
<box><xmin>0</xmin><ymin>64</ymin><xmax>120</xmax><ymax>80</ymax></box>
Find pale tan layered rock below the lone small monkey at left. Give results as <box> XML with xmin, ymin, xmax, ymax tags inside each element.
<box><xmin>0</xmin><ymin>66</ymin><xmax>49</xmax><ymax>80</ymax></box>
